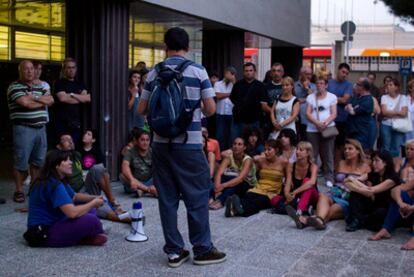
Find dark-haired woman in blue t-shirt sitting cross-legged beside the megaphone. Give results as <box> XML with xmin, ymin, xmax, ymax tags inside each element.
<box><xmin>24</xmin><ymin>150</ymin><xmax>107</xmax><ymax>247</ymax></box>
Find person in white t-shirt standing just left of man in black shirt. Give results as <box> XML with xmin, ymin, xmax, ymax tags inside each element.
<box><xmin>214</xmin><ymin>66</ymin><xmax>236</xmax><ymax>150</ymax></box>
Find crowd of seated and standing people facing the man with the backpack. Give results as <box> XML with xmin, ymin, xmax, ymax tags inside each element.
<box><xmin>4</xmin><ymin>48</ymin><xmax>414</xmax><ymax>250</ymax></box>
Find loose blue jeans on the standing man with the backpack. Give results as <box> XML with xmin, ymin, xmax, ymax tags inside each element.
<box><xmin>152</xmin><ymin>144</ymin><xmax>213</xmax><ymax>256</ymax></box>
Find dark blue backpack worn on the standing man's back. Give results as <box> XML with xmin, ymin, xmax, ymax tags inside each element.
<box><xmin>147</xmin><ymin>60</ymin><xmax>201</xmax><ymax>143</ymax></box>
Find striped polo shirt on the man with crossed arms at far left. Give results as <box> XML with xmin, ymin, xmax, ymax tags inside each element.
<box><xmin>7</xmin><ymin>81</ymin><xmax>48</xmax><ymax>127</ymax></box>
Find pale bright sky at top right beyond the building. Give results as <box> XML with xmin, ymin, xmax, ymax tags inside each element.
<box><xmin>311</xmin><ymin>0</ymin><xmax>414</xmax><ymax>31</ymax></box>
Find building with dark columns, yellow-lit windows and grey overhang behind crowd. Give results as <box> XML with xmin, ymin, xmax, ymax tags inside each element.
<box><xmin>0</xmin><ymin>0</ymin><xmax>310</xmax><ymax>178</ymax></box>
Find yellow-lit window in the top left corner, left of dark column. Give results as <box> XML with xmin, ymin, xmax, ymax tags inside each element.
<box><xmin>0</xmin><ymin>0</ymin><xmax>65</xmax><ymax>61</ymax></box>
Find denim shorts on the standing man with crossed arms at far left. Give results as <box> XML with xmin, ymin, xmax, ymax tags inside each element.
<box><xmin>13</xmin><ymin>125</ymin><xmax>47</xmax><ymax>171</ymax></box>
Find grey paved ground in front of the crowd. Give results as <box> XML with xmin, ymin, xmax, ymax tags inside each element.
<box><xmin>0</xmin><ymin>181</ymin><xmax>414</xmax><ymax>277</ymax></box>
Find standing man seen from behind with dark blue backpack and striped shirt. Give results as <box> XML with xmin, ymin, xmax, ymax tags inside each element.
<box><xmin>138</xmin><ymin>27</ymin><xmax>226</xmax><ymax>267</ymax></box>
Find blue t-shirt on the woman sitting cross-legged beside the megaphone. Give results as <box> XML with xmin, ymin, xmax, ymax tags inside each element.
<box><xmin>27</xmin><ymin>178</ymin><xmax>75</xmax><ymax>228</ymax></box>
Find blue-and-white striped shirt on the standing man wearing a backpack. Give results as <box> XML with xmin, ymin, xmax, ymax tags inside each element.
<box><xmin>141</xmin><ymin>56</ymin><xmax>215</xmax><ymax>150</ymax></box>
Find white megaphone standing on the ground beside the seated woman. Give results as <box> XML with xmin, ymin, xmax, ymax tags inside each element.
<box><xmin>119</xmin><ymin>202</ymin><xmax>148</xmax><ymax>242</ymax></box>
